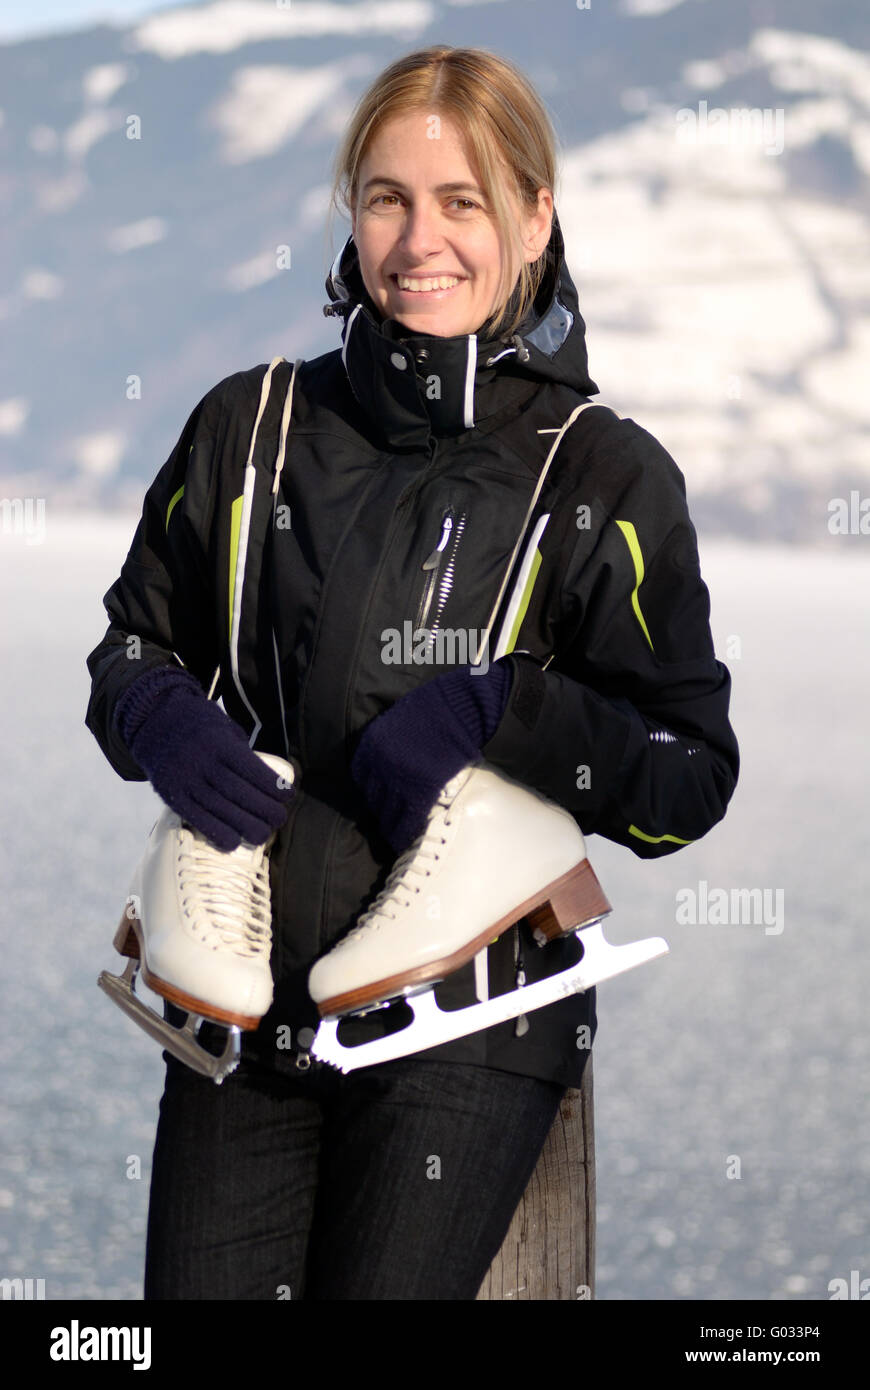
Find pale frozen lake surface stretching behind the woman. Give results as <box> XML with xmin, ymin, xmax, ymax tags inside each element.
<box><xmin>0</xmin><ymin>517</ymin><xmax>870</xmax><ymax>1300</ymax></box>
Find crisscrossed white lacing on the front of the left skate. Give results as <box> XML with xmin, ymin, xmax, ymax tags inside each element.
<box><xmin>178</xmin><ymin>830</ymin><xmax>272</xmax><ymax>956</ymax></box>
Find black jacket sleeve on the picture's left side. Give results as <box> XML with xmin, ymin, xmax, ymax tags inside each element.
<box><xmin>85</xmin><ymin>386</ymin><xmax>220</xmax><ymax>781</ymax></box>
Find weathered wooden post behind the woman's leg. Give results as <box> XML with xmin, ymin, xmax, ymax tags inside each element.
<box><xmin>477</xmin><ymin>1054</ymin><xmax>595</xmax><ymax>1300</ymax></box>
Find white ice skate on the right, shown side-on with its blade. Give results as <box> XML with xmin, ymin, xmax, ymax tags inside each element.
<box><xmin>309</xmin><ymin>760</ymin><xmax>668</xmax><ymax>1072</ymax></box>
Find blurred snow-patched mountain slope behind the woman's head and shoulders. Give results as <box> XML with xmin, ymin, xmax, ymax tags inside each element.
<box><xmin>0</xmin><ymin>0</ymin><xmax>870</xmax><ymax>545</ymax></box>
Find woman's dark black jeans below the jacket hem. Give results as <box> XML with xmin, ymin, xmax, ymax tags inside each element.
<box><xmin>145</xmin><ymin>1056</ymin><xmax>564</xmax><ymax>1300</ymax></box>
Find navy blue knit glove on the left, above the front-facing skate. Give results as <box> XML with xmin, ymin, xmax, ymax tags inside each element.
<box><xmin>114</xmin><ymin>666</ymin><xmax>293</xmax><ymax>851</ymax></box>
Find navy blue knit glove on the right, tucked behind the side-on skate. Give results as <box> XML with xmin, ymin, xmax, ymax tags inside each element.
<box><xmin>350</xmin><ymin>657</ymin><xmax>513</xmax><ymax>853</ymax></box>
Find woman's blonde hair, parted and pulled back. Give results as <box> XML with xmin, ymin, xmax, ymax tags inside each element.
<box><xmin>329</xmin><ymin>43</ymin><xmax>556</xmax><ymax>336</ymax></box>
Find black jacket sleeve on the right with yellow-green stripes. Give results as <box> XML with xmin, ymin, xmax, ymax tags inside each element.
<box><xmin>482</xmin><ymin>421</ymin><xmax>739</xmax><ymax>859</ymax></box>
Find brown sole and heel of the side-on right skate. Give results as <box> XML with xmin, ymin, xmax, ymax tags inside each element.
<box><xmin>317</xmin><ymin>859</ymin><xmax>613</xmax><ymax>1017</ymax></box>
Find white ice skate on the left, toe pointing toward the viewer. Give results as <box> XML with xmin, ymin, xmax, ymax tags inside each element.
<box><xmin>97</xmin><ymin>749</ymin><xmax>297</xmax><ymax>1084</ymax></box>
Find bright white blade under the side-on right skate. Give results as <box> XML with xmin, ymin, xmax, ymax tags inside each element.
<box><xmin>310</xmin><ymin>923</ymin><xmax>668</xmax><ymax>1072</ymax></box>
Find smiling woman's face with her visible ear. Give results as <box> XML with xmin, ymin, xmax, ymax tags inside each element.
<box><xmin>352</xmin><ymin>111</ymin><xmax>553</xmax><ymax>338</ymax></box>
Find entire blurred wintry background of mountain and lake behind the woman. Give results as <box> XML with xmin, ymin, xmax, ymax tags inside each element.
<box><xmin>0</xmin><ymin>0</ymin><xmax>870</xmax><ymax>1300</ymax></box>
